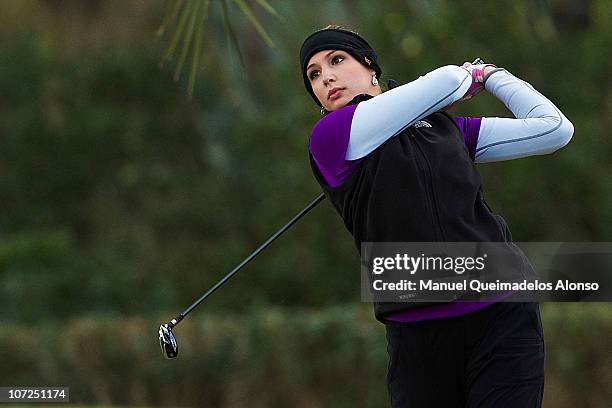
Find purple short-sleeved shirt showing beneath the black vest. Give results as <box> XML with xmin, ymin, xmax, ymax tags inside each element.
<box><xmin>308</xmin><ymin>111</ymin><xmax>505</xmax><ymax>322</ymax></box>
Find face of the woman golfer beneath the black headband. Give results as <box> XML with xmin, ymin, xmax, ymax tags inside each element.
<box><xmin>306</xmin><ymin>50</ymin><xmax>381</xmax><ymax>112</ymax></box>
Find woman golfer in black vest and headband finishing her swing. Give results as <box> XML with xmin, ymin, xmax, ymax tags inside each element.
<box><xmin>300</xmin><ymin>27</ymin><xmax>573</xmax><ymax>408</ymax></box>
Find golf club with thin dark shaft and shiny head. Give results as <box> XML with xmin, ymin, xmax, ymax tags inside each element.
<box><xmin>159</xmin><ymin>193</ymin><xmax>325</xmax><ymax>358</ymax></box>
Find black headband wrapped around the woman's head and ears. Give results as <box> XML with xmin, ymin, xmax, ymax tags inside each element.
<box><xmin>300</xmin><ymin>28</ymin><xmax>382</xmax><ymax>106</ymax></box>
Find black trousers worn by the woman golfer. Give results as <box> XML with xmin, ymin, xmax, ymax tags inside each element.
<box><xmin>385</xmin><ymin>302</ymin><xmax>544</xmax><ymax>408</ymax></box>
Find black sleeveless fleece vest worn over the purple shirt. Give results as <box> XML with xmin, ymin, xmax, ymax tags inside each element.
<box><xmin>309</xmin><ymin>95</ymin><xmax>520</xmax><ymax>322</ymax></box>
